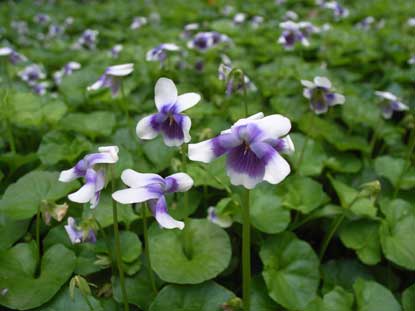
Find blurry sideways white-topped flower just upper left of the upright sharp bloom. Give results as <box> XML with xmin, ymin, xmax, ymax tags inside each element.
<box><xmin>87</xmin><ymin>64</ymin><xmax>134</xmax><ymax>97</ymax></box>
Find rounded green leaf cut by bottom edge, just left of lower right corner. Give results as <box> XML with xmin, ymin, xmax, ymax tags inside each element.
<box><xmin>353</xmin><ymin>279</ymin><xmax>401</xmax><ymax>311</ymax></box>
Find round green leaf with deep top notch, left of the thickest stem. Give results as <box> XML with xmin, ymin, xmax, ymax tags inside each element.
<box><xmin>149</xmin><ymin>219</ymin><xmax>231</xmax><ymax>284</ymax></box>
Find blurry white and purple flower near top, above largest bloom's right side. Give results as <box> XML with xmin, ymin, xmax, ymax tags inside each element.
<box><xmin>278</xmin><ymin>21</ymin><xmax>319</xmax><ymax>50</ymax></box>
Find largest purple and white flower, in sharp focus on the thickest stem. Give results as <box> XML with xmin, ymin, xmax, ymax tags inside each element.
<box><xmin>189</xmin><ymin>112</ymin><xmax>294</xmax><ymax>189</ymax></box>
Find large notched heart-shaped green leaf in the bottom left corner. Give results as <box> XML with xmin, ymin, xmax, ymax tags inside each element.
<box><xmin>0</xmin><ymin>244</ymin><xmax>76</xmax><ymax>310</ymax></box>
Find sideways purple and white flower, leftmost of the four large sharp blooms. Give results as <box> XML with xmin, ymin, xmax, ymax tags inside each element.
<box><xmin>59</xmin><ymin>146</ymin><xmax>118</xmax><ymax>208</ymax></box>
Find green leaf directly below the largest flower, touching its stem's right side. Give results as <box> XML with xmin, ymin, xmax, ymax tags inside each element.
<box><xmin>250</xmin><ymin>184</ymin><xmax>290</xmax><ymax>233</ymax></box>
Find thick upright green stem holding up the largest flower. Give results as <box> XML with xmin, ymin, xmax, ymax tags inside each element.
<box><xmin>242</xmin><ymin>189</ymin><xmax>251</xmax><ymax>311</ymax></box>
